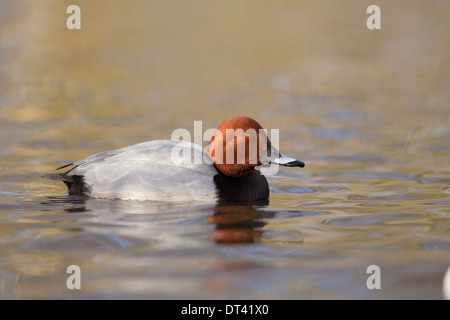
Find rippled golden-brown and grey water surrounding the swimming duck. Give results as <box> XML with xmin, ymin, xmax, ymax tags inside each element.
<box><xmin>0</xmin><ymin>0</ymin><xmax>450</xmax><ymax>299</ymax></box>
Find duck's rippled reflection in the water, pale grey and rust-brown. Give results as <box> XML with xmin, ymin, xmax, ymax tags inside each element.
<box><xmin>41</xmin><ymin>196</ymin><xmax>274</xmax><ymax>243</ymax></box>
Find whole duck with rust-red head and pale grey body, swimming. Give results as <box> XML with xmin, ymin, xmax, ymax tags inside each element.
<box><xmin>44</xmin><ymin>116</ymin><xmax>305</xmax><ymax>204</ymax></box>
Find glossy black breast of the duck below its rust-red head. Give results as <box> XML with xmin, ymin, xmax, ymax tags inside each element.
<box><xmin>214</xmin><ymin>170</ymin><xmax>269</xmax><ymax>203</ymax></box>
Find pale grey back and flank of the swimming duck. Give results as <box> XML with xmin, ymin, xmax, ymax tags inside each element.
<box><xmin>61</xmin><ymin>140</ymin><xmax>221</xmax><ymax>202</ymax></box>
